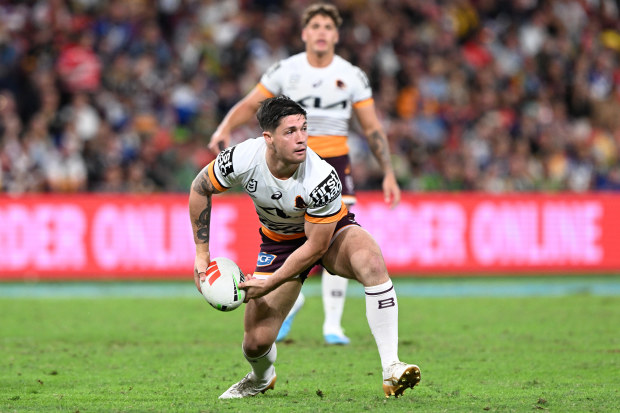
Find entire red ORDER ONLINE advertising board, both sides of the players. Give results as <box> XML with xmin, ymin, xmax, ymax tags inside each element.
<box><xmin>0</xmin><ymin>193</ymin><xmax>620</xmax><ymax>280</ymax></box>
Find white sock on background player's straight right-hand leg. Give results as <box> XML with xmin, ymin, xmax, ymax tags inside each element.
<box><xmin>321</xmin><ymin>269</ymin><xmax>349</xmax><ymax>335</ymax></box>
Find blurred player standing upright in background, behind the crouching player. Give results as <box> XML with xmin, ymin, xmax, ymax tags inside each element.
<box><xmin>209</xmin><ymin>3</ymin><xmax>400</xmax><ymax>344</ymax></box>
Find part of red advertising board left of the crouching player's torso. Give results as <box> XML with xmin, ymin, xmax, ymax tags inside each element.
<box><xmin>0</xmin><ymin>194</ymin><xmax>259</xmax><ymax>279</ymax></box>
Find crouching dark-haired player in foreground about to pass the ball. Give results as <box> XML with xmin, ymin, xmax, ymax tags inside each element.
<box><xmin>189</xmin><ymin>96</ymin><xmax>420</xmax><ymax>399</ymax></box>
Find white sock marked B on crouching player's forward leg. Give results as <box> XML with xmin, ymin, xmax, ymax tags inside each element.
<box><xmin>364</xmin><ymin>280</ymin><xmax>398</xmax><ymax>371</ymax></box>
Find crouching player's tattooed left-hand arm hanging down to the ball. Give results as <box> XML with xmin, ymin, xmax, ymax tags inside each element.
<box><xmin>189</xmin><ymin>166</ymin><xmax>225</xmax><ymax>291</ymax></box>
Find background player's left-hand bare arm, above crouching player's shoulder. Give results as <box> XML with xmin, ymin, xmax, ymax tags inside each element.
<box><xmin>208</xmin><ymin>85</ymin><xmax>269</xmax><ymax>153</ymax></box>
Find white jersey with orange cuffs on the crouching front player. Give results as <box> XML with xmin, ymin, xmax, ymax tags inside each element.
<box><xmin>208</xmin><ymin>137</ymin><xmax>347</xmax><ymax>241</ymax></box>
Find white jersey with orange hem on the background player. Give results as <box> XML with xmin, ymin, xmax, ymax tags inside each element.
<box><xmin>258</xmin><ymin>52</ymin><xmax>372</xmax><ymax>158</ymax></box>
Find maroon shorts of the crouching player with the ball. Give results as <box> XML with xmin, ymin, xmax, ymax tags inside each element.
<box><xmin>254</xmin><ymin>212</ymin><xmax>359</xmax><ymax>282</ymax></box>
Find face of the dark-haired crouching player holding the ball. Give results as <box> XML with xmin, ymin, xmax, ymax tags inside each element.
<box><xmin>267</xmin><ymin>115</ymin><xmax>308</xmax><ymax>165</ymax></box>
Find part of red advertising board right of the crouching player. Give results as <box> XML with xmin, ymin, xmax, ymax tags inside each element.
<box><xmin>354</xmin><ymin>194</ymin><xmax>620</xmax><ymax>274</ymax></box>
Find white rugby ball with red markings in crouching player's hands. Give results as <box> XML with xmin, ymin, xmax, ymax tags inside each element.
<box><xmin>200</xmin><ymin>257</ymin><xmax>245</xmax><ymax>311</ymax></box>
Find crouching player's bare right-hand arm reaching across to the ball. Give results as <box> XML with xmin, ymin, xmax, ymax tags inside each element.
<box><xmin>239</xmin><ymin>221</ymin><xmax>337</xmax><ymax>302</ymax></box>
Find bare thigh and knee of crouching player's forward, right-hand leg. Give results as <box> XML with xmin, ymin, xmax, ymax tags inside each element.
<box><xmin>322</xmin><ymin>225</ymin><xmax>389</xmax><ymax>286</ymax></box>
